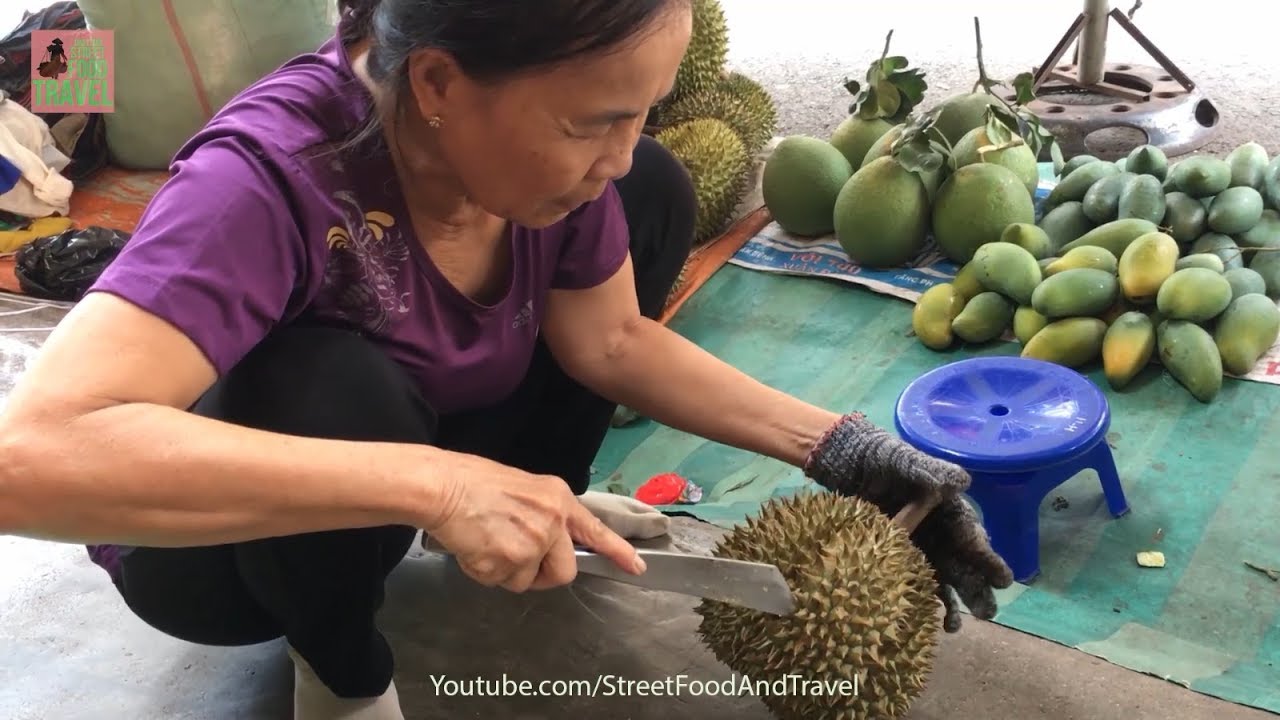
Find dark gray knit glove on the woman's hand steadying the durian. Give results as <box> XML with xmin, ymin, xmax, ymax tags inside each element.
<box><xmin>804</xmin><ymin>413</ymin><xmax>1014</xmax><ymax>633</ymax></box>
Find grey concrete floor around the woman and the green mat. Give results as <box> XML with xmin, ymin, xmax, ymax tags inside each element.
<box><xmin>0</xmin><ymin>0</ymin><xmax>1280</xmax><ymax>720</ymax></box>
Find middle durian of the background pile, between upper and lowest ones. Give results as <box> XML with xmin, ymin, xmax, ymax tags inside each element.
<box><xmin>658</xmin><ymin>73</ymin><xmax>778</xmax><ymax>155</ymax></box>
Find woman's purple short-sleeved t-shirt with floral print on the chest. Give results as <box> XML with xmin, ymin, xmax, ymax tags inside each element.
<box><xmin>81</xmin><ymin>28</ymin><xmax>630</xmax><ymax>579</ymax></box>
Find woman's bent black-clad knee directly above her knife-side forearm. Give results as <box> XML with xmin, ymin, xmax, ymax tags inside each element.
<box><xmin>193</xmin><ymin>324</ymin><xmax>436</xmax><ymax>443</ymax></box>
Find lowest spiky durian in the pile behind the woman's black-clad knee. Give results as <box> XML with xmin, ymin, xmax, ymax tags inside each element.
<box><xmin>655</xmin><ymin>118</ymin><xmax>751</xmax><ymax>245</ymax></box>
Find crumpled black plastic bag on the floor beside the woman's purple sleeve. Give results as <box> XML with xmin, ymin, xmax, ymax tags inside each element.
<box><xmin>14</xmin><ymin>225</ymin><xmax>131</xmax><ymax>301</ymax></box>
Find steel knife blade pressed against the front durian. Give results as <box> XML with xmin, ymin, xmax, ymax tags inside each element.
<box><xmin>576</xmin><ymin>548</ymin><xmax>795</xmax><ymax>615</ymax></box>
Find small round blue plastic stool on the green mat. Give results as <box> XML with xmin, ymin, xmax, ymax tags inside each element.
<box><xmin>895</xmin><ymin>356</ymin><xmax>1129</xmax><ymax>583</ymax></box>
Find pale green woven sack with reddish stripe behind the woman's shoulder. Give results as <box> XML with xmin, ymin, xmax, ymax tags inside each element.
<box><xmin>79</xmin><ymin>0</ymin><xmax>338</xmax><ymax>170</ymax></box>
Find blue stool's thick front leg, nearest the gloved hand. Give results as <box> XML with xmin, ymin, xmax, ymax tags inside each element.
<box><xmin>968</xmin><ymin>474</ymin><xmax>1044</xmax><ymax>583</ymax></box>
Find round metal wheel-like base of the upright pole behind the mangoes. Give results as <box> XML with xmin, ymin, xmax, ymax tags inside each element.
<box><xmin>1006</xmin><ymin>63</ymin><xmax>1221</xmax><ymax>160</ymax></box>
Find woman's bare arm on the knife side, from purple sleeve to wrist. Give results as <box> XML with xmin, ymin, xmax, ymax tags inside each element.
<box><xmin>0</xmin><ymin>293</ymin><xmax>460</xmax><ymax>546</ymax></box>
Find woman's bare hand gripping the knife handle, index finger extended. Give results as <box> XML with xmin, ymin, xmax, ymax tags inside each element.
<box><xmin>424</xmin><ymin>456</ymin><xmax>644</xmax><ymax>592</ymax></box>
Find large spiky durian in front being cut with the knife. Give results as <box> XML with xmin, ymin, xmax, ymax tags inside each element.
<box><xmin>698</xmin><ymin>491</ymin><xmax>941</xmax><ymax>720</ymax></box>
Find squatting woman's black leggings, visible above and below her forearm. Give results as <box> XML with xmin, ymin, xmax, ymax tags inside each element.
<box><xmin>113</xmin><ymin>137</ymin><xmax>695</xmax><ymax>697</ymax></box>
